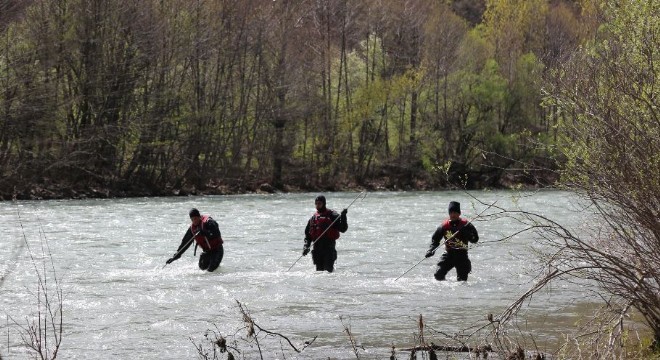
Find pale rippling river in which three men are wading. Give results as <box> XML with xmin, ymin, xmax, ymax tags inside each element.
<box><xmin>0</xmin><ymin>191</ymin><xmax>590</xmax><ymax>359</ymax></box>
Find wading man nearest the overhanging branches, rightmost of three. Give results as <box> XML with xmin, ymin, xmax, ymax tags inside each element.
<box><xmin>426</xmin><ymin>201</ymin><xmax>479</xmax><ymax>281</ymax></box>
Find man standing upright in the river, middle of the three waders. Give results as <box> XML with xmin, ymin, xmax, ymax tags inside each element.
<box><xmin>303</xmin><ymin>195</ymin><xmax>348</xmax><ymax>272</ymax></box>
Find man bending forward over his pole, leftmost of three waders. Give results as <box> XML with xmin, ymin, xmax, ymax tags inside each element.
<box><xmin>165</xmin><ymin>208</ymin><xmax>225</xmax><ymax>271</ymax></box>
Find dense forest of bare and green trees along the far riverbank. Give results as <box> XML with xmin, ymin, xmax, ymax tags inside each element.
<box><xmin>0</xmin><ymin>0</ymin><xmax>588</xmax><ymax>200</ymax></box>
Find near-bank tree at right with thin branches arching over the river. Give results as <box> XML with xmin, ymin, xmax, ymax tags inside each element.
<box><xmin>503</xmin><ymin>1</ymin><xmax>660</xmax><ymax>357</ymax></box>
